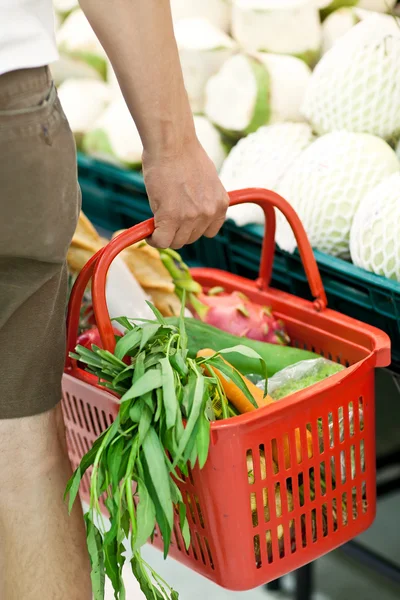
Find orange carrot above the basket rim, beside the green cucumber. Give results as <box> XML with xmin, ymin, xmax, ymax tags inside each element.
<box><xmin>197</xmin><ymin>348</ymin><xmax>274</xmax><ymax>414</ymax></box>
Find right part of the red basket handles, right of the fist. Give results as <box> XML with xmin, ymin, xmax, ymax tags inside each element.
<box><xmin>229</xmin><ymin>188</ymin><xmax>328</xmax><ymax>311</ymax></box>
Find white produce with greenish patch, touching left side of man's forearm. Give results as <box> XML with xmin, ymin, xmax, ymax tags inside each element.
<box><xmin>83</xmin><ymin>96</ymin><xmax>143</xmax><ymax>169</ymax></box>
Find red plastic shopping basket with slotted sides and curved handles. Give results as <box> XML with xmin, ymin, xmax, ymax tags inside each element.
<box><xmin>63</xmin><ymin>189</ymin><xmax>390</xmax><ymax>591</ymax></box>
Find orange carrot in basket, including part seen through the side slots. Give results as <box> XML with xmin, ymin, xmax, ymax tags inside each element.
<box><xmin>197</xmin><ymin>348</ymin><xmax>313</xmax><ymax>469</ymax></box>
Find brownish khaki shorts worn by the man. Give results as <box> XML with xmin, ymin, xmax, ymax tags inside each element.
<box><xmin>0</xmin><ymin>67</ymin><xmax>80</xmax><ymax>419</ymax></box>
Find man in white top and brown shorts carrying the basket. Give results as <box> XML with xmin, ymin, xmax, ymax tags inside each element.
<box><xmin>0</xmin><ymin>0</ymin><xmax>228</xmax><ymax>600</ymax></box>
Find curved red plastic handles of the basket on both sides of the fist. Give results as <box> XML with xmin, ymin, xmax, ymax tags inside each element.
<box><xmin>67</xmin><ymin>188</ymin><xmax>327</xmax><ymax>361</ymax></box>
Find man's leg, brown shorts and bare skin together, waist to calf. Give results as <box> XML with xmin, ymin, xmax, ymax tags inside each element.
<box><xmin>0</xmin><ymin>68</ymin><xmax>92</xmax><ymax>600</ymax></box>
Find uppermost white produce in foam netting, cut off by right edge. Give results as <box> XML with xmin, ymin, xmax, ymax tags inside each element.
<box><xmin>303</xmin><ymin>13</ymin><xmax>400</xmax><ymax>139</ymax></box>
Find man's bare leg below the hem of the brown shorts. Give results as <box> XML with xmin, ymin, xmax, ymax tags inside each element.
<box><xmin>0</xmin><ymin>405</ymin><xmax>92</xmax><ymax>600</ymax></box>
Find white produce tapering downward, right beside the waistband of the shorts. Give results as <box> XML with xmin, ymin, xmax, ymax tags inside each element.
<box><xmin>58</xmin><ymin>79</ymin><xmax>111</xmax><ymax>146</ymax></box>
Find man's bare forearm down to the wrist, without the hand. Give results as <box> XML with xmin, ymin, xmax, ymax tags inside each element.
<box><xmin>80</xmin><ymin>0</ymin><xmax>195</xmax><ymax>155</ymax></box>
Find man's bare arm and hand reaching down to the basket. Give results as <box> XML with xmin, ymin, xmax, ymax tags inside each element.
<box><xmin>80</xmin><ymin>0</ymin><xmax>228</xmax><ymax>248</ymax></box>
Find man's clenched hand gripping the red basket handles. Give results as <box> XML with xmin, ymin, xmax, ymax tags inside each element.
<box><xmin>143</xmin><ymin>139</ymin><xmax>229</xmax><ymax>249</ymax></box>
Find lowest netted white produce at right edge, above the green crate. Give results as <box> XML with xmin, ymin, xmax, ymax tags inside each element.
<box><xmin>350</xmin><ymin>173</ymin><xmax>400</xmax><ymax>281</ymax></box>
